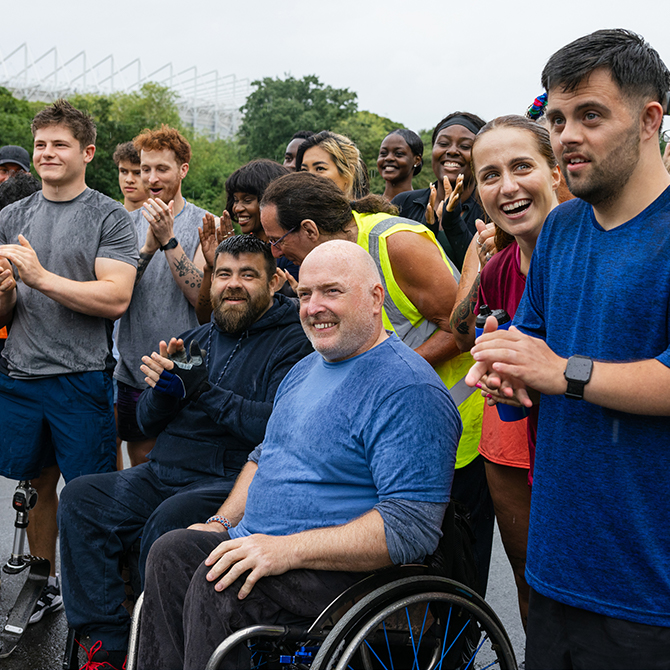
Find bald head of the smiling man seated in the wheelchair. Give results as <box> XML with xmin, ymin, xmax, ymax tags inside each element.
<box><xmin>298</xmin><ymin>240</ymin><xmax>387</xmax><ymax>362</ymax></box>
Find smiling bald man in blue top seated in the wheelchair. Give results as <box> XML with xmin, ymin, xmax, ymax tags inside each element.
<box><xmin>139</xmin><ymin>240</ymin><xmax>461</xmax><ymax>668</ymax></box>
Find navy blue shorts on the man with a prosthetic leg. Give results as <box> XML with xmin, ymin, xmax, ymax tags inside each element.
<box><xmin>0</xmin><ymin>372</ymin><xmax>116</xmax><ymax>482</ymax></box>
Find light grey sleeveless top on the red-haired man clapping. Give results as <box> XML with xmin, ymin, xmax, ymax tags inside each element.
<box><xmin>114</xmin><ymin>200</ymin><xmax>206</xmax><ymax>389</ymax></box>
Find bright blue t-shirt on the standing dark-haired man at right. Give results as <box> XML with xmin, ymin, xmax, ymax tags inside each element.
<box><xmin>514</xmin><ymin>188</ymin><xmax>670</xmax><ymax>626</ymax></box>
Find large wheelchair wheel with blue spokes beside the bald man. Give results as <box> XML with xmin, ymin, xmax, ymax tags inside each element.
<box><xmin>312</xmin><ymin>576</ymin><xmax>517</xmax><ymax>670</ymax></box>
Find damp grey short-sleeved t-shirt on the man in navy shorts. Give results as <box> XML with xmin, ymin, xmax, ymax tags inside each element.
<box><xmin>0</xmin><ymin>188</ymin><xmax>139</xmax><ymax>379</ymax></box>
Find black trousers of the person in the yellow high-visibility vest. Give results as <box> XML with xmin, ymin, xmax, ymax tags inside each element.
<box><xmin>451</xmin><ymin>456</ymin><xmax>495</xmax><ymax>598</ymax></box>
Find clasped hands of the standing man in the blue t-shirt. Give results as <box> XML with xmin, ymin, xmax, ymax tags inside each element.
<box><xmin>465</xmin><ymin>316</ymin><xmax>567</xmax><ymax>407</ymax></box>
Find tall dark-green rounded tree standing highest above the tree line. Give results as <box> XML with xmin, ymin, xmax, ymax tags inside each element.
<box><xmin>240</xmin><ymin>75</ymin><xmax>358</xmax><ymax>160</ymax></box>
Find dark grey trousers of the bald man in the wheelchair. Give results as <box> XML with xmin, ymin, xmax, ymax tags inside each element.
<box><xmin>138</xmin><ymin>530</ymin><xmax>364</xmax><ymax>670</ymax></box>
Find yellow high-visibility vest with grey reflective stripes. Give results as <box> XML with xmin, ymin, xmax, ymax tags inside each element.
<box><xmin>354</xmin><ymin>212</ymin><xmax>484</xmax><ymax>468</ymax></box>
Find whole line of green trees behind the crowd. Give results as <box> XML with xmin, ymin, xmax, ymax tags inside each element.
<box><xmin>0</xmin><ymin>75</ymin><xmax>434</xmax><ymax>214</ymax></box>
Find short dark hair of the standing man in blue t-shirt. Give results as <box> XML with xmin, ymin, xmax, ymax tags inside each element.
<box><xmin>542</xmin><ymin>28</ymin><xmax>670</xmax><ymax>104</ymax></box>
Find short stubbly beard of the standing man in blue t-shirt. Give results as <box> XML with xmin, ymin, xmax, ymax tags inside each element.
<box><xmin>561</xmin><ymin>119</ymin><xmax>640</xmax><ymax>207</ymax></box>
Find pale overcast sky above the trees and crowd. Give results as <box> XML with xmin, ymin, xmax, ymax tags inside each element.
<box><xmin>0</xmin><ymin>0</ymin><xmax>670</xmax><ymax>130</ymax></box>
